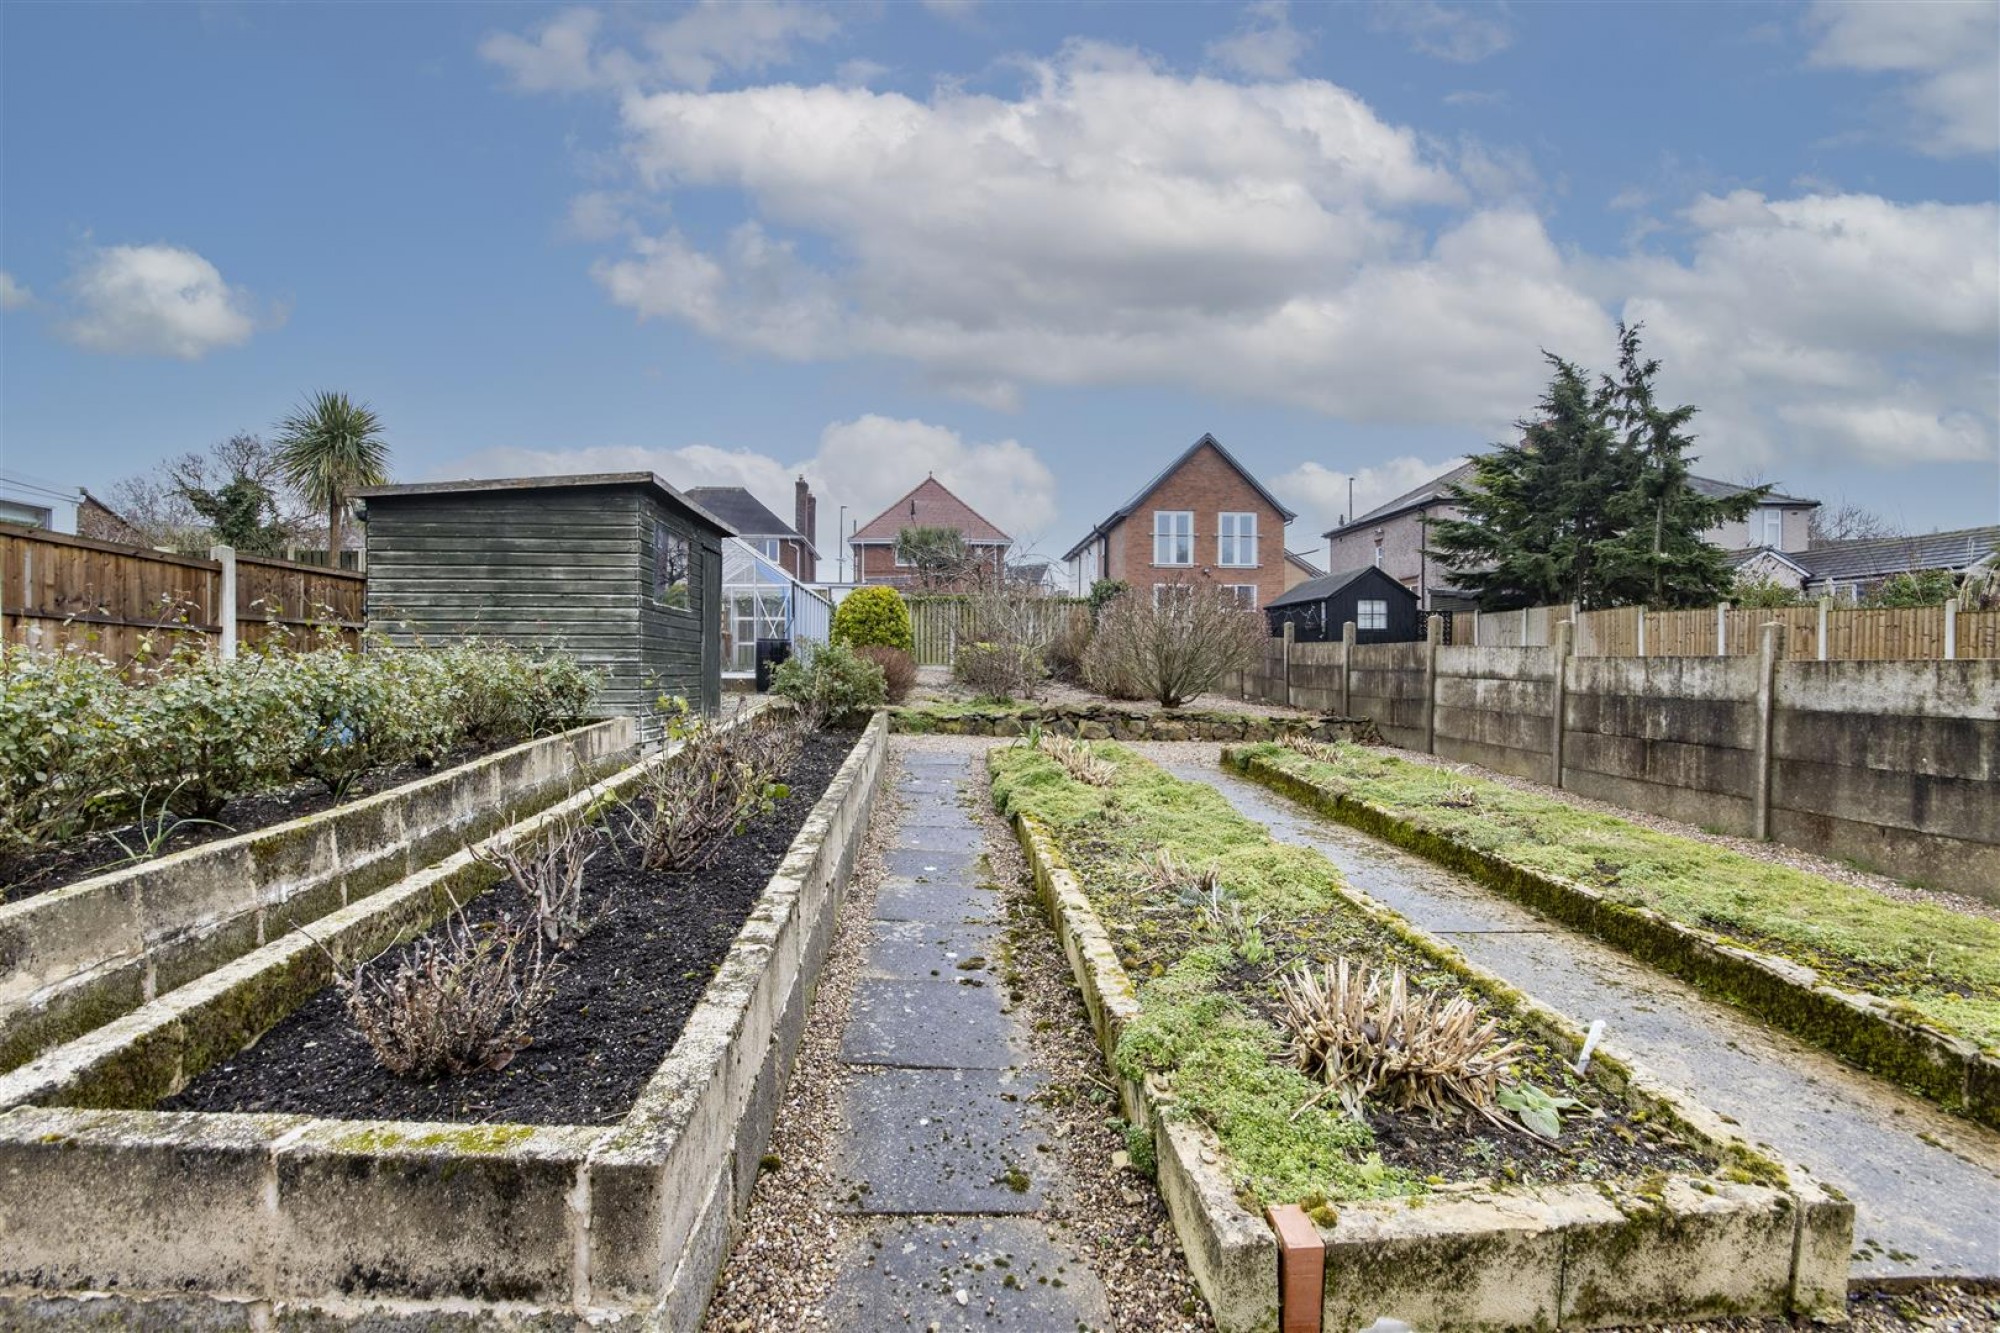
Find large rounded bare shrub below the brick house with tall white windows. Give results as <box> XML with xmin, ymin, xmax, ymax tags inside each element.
<box><xmin>1084</xmin><ymin>578</ymin><xmax>1266</xmax><ymax>709</ymax></box>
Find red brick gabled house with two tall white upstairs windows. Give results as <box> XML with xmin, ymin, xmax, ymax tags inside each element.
<box><xmin>1062</xmin><ymin>434</ymin><xmax>1298</xmax><ymax>608</ymax></box>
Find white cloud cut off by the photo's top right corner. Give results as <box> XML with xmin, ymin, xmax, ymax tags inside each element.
<box><xmin>1810</xmin><ymin>0</ymin><xmax>2000</xmax><ymax>156</ymax></box>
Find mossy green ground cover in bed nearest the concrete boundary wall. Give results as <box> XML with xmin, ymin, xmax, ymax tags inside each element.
<box><xmin>1230</xmin><ymin>745</ymin><xmax>2000</xmax><ymax>1053</ymax></box>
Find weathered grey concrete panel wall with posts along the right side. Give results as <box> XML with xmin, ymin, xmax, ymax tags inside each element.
<box><xmin>1228</xmin><ymin>616</ymin><xmax>2000</xmax><ymax>903</ymax></box>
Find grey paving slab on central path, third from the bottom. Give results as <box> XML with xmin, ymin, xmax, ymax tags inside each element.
<box><xmin>840</xmin><ymin>977</ymin><xmax>1018</xmax><ymax>1069</ymax></box>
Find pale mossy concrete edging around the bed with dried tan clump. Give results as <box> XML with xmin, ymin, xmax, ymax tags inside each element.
<box><xmin>996</xmin><ymin>764</ymin><xmax>1854</xmax><ymax>1333</ymax></box>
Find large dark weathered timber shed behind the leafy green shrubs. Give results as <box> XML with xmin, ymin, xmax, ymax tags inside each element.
<box><xmin>360</xmin><ymin>472</ymin><xmax>734</xmax><ymax>741</ymax></box>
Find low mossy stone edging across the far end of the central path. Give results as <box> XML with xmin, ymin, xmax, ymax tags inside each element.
<box><xmin>888</xmin><ymin>705</ymin><xmax>1380</xmax><ymax>741</ymax></box>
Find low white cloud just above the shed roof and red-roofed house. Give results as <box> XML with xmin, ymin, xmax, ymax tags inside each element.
<box><xmin>434</xmin><ymin>414</ymin><xmax>1056</xmax><ymax>548</ymax></box>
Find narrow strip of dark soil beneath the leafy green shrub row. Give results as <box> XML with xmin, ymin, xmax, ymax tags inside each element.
<box><xmin>0</xmin><ymin>741</ymin><xmax>520</xmax><ymax>903</ymax></box>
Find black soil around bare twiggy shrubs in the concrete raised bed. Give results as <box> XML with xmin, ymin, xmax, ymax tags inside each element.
<box><xmin>160</xmin><ymin>733</ymin><xmax>854</xmax><ymax>1125</ymax></box>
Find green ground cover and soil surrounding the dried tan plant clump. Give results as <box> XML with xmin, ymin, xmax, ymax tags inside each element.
<box><xmin>990</xmin><ymin>743</ymin><xmax>1720</xmax><ymax>1209</ymax></box>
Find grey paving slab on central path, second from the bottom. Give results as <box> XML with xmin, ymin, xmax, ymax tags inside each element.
<box><xmin>836</xmin><ymin>1069</ymin><xmax>1042</xmax><ymax>1215</ymax></box>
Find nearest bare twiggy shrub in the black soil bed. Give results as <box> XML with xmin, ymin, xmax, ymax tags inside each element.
<box><xmin>334</xmin><ymin>911</ymin><xmax>558</xmax><ymax>1081</ymax></box>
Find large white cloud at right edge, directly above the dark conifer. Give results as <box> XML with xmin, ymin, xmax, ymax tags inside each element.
<box><xmin>1608</xmin><ymin>190</ymin><xmax>2000</xmax><ymax>472</ymax></box>
